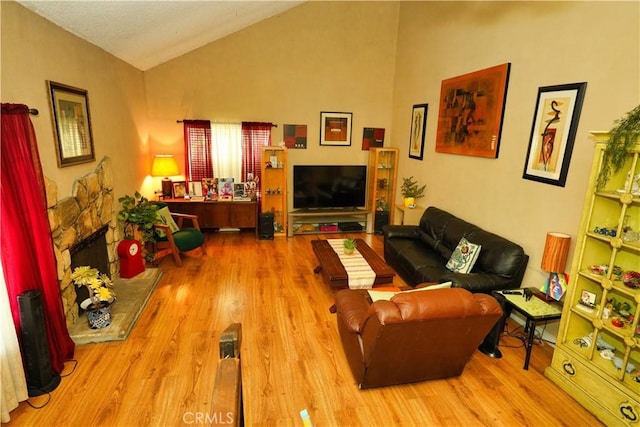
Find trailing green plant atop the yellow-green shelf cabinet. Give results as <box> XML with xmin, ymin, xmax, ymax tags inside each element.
<box><xmin>596</xmin><ymin>105</ymin><xmax>640</xmax><ymax>189</ymax></box>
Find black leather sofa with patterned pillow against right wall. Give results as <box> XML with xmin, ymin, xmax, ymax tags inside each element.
<box><xmin>382</xmin><ymin>206</ymin><xmax>529</xmax><ymax>293</ymax></box>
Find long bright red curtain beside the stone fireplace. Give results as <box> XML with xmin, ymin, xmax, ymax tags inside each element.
<box><xmin>0</xmin><ymin>103</ymin><xmax>74</xmax><ymax>373</ymax></box>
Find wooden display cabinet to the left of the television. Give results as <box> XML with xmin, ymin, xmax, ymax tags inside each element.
<box><xmin>260</xmin><ymin>147</ymin><xmax>287</xmax><ymax>236</ymax></box>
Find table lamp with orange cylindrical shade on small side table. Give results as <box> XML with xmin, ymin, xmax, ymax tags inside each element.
<box><xmin>540</xmin><ymin>232</ymin><xmax>571</xmax><ymax>301</ymax></box>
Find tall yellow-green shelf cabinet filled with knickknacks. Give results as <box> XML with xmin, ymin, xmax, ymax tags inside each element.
<box><xmin>545</xmin><ymin>133</ymin><xmax>640</xmax><ymax>426</ymax></box>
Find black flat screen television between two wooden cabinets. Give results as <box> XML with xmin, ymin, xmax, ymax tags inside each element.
<box><xmin>293</xmin><ymin>165</ymin><xmax>367</xmax><ymax>209</ymax></box>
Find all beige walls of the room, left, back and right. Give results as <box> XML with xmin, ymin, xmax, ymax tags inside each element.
<box><xmin>1</xmin><ymin>1</ymin><xmax>640</xmax><ymax>298</ymax></box>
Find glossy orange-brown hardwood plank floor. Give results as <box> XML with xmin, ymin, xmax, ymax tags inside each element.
<box><xmin>10</xmin><ymin>232</ymin><xmax>600</xmax><ymax>426</ymax></box>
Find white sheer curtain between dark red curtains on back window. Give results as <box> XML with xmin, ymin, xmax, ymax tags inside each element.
<box><xmin>211</xmin><ymin>123</ymin><xmax>242</xmax><ymax>182</ymax></box>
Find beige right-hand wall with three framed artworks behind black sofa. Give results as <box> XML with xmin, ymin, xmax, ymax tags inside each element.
<box><xmin>392</xmin><ymin>2</ymin><xmax>640</xmax><ymax>292</ymax></box>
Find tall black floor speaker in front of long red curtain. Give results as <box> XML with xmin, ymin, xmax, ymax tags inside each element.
<box><xmin>18</xmin><ymin>291</ymin><xmax>60</xmax><ymax>396</ymax></box>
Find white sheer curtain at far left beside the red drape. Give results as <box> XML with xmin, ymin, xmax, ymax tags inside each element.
<box><xmin>0</xmin><ymin>264</ymin><xmax>29</xmax><ymax>423</ymax></box>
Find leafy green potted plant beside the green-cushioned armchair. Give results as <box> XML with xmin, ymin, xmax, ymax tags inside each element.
<box><xmin>118</xmin><ymin>191</ymin><xmax>158</xmax><ymax>260</ymax></box>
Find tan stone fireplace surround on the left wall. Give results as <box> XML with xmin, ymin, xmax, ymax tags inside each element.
<box><xmin>45</xmin><ymin>157</ymin><xmax>120</xmax><ymax>326</ymax></box>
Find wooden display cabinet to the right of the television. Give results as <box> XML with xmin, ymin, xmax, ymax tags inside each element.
<box><xmin>367</xmin><ymin>148</ymin><xmax>398</xmax><ymax>224</ymax></box>
